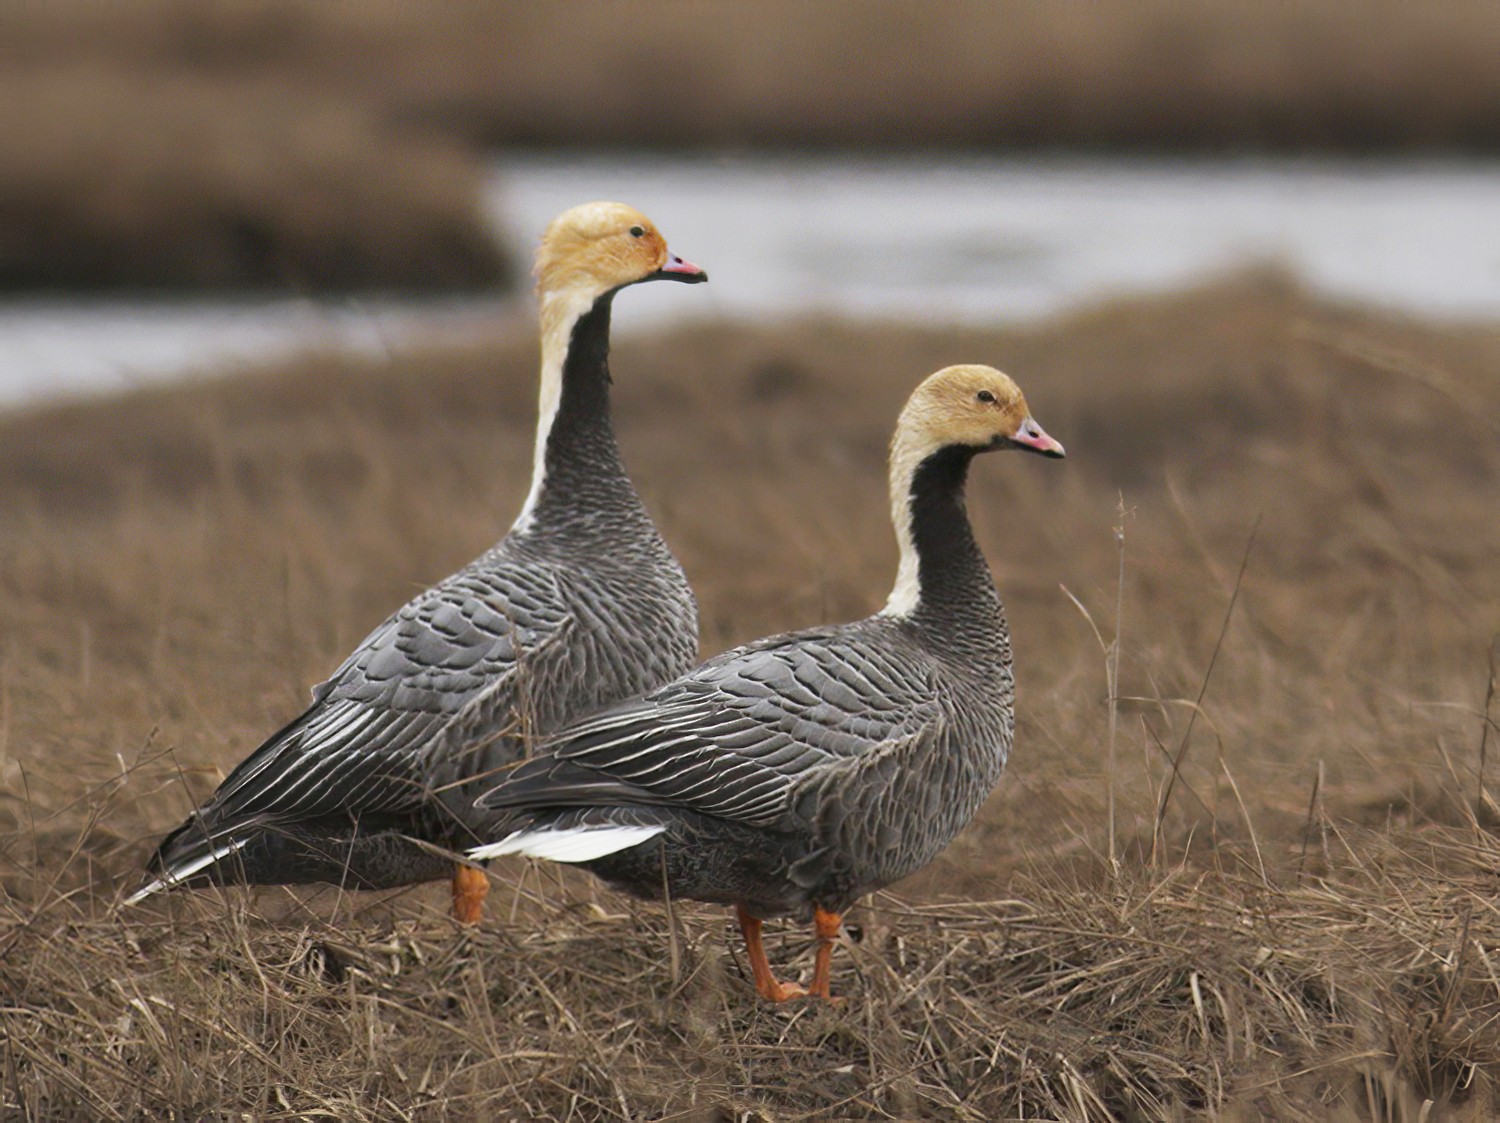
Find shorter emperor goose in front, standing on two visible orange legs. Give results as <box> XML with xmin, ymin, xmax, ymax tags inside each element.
<box><xmin>471</xmin><ymin>366</ymin><xmax>1064</xmax><ymax>1002</ymax></box>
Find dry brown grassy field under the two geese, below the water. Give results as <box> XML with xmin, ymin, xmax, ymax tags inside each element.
<box><xmin>0</xmin><ymin>276</ymin><xmax>1500</xmax><ymax>1123</ymax></box>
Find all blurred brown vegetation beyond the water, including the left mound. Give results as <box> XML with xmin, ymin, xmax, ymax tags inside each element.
<box><xmin>0</xmin><ymin>0</ymin><xmax>1500</xmax><ymax>291</ymax></box>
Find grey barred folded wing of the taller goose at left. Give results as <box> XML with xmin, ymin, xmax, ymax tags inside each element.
<box><xmin>187</xmin><ymin>559</ymin><xmax>569</xmax><ymax>828</ymax></box>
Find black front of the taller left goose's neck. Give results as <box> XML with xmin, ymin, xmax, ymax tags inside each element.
<box><xmin>536</xmin><ymin>292</ymin><xmax>639</xmax><ymax>523</ymax></box>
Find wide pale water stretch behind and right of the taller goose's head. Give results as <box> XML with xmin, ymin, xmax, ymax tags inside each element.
<box><xmin>498</xmin><ymin>157</ymin><xmax>1500</xmax><ymax>322</ymax></box>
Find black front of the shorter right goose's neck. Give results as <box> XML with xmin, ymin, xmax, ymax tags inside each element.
<box><xmin>909</xmin><ymin>447</ymin><xmax>1001</xmax><ymax>640</ymax></box>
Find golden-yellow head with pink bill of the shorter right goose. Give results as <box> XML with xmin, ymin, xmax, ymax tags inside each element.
<box><xmin>893</xmin><ymin>366</ymin><xmax>1064</xmax><ymax>466</ymax></box>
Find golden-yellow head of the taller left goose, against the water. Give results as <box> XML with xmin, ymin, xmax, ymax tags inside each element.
<box><xmin>536</xmin><ymin>202</ymin><xmax>708</xmax><ymax>295</ymax></box>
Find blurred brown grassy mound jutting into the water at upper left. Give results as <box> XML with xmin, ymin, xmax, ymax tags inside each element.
<box><xmin>0</xmin><ymin>61</ymin><xmax>510</xmax><ymax>292</ymax></box>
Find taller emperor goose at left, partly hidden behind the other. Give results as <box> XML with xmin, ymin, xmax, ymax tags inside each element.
<box><xmin>129</xmin><ymin>202</ymin><xmax>708</xmax><ymax>922</ymax></box>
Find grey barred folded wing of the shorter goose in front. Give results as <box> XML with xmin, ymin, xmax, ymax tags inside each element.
<box><xmin>477</xmin><ymin>625</ymin><xmax>939</xmax><ymax>825</ymax></box>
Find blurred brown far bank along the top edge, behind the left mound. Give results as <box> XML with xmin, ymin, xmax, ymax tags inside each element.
<box><xmin>12</xmin><ymin>0</ymin><xmax>1500</xmax><ymax>151</ymax></box>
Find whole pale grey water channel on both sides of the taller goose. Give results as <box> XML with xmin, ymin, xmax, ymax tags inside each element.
<box><xmin>0</xmin><ymin>156</ymin><xmax>1500</xmax><ymax>403</ymax></box>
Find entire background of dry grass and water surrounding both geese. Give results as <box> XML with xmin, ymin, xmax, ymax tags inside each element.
<box><xmin>0</xmin><ymin>0</ymin><xmax>1500</xmax><ymax>1123</ymax></box>
